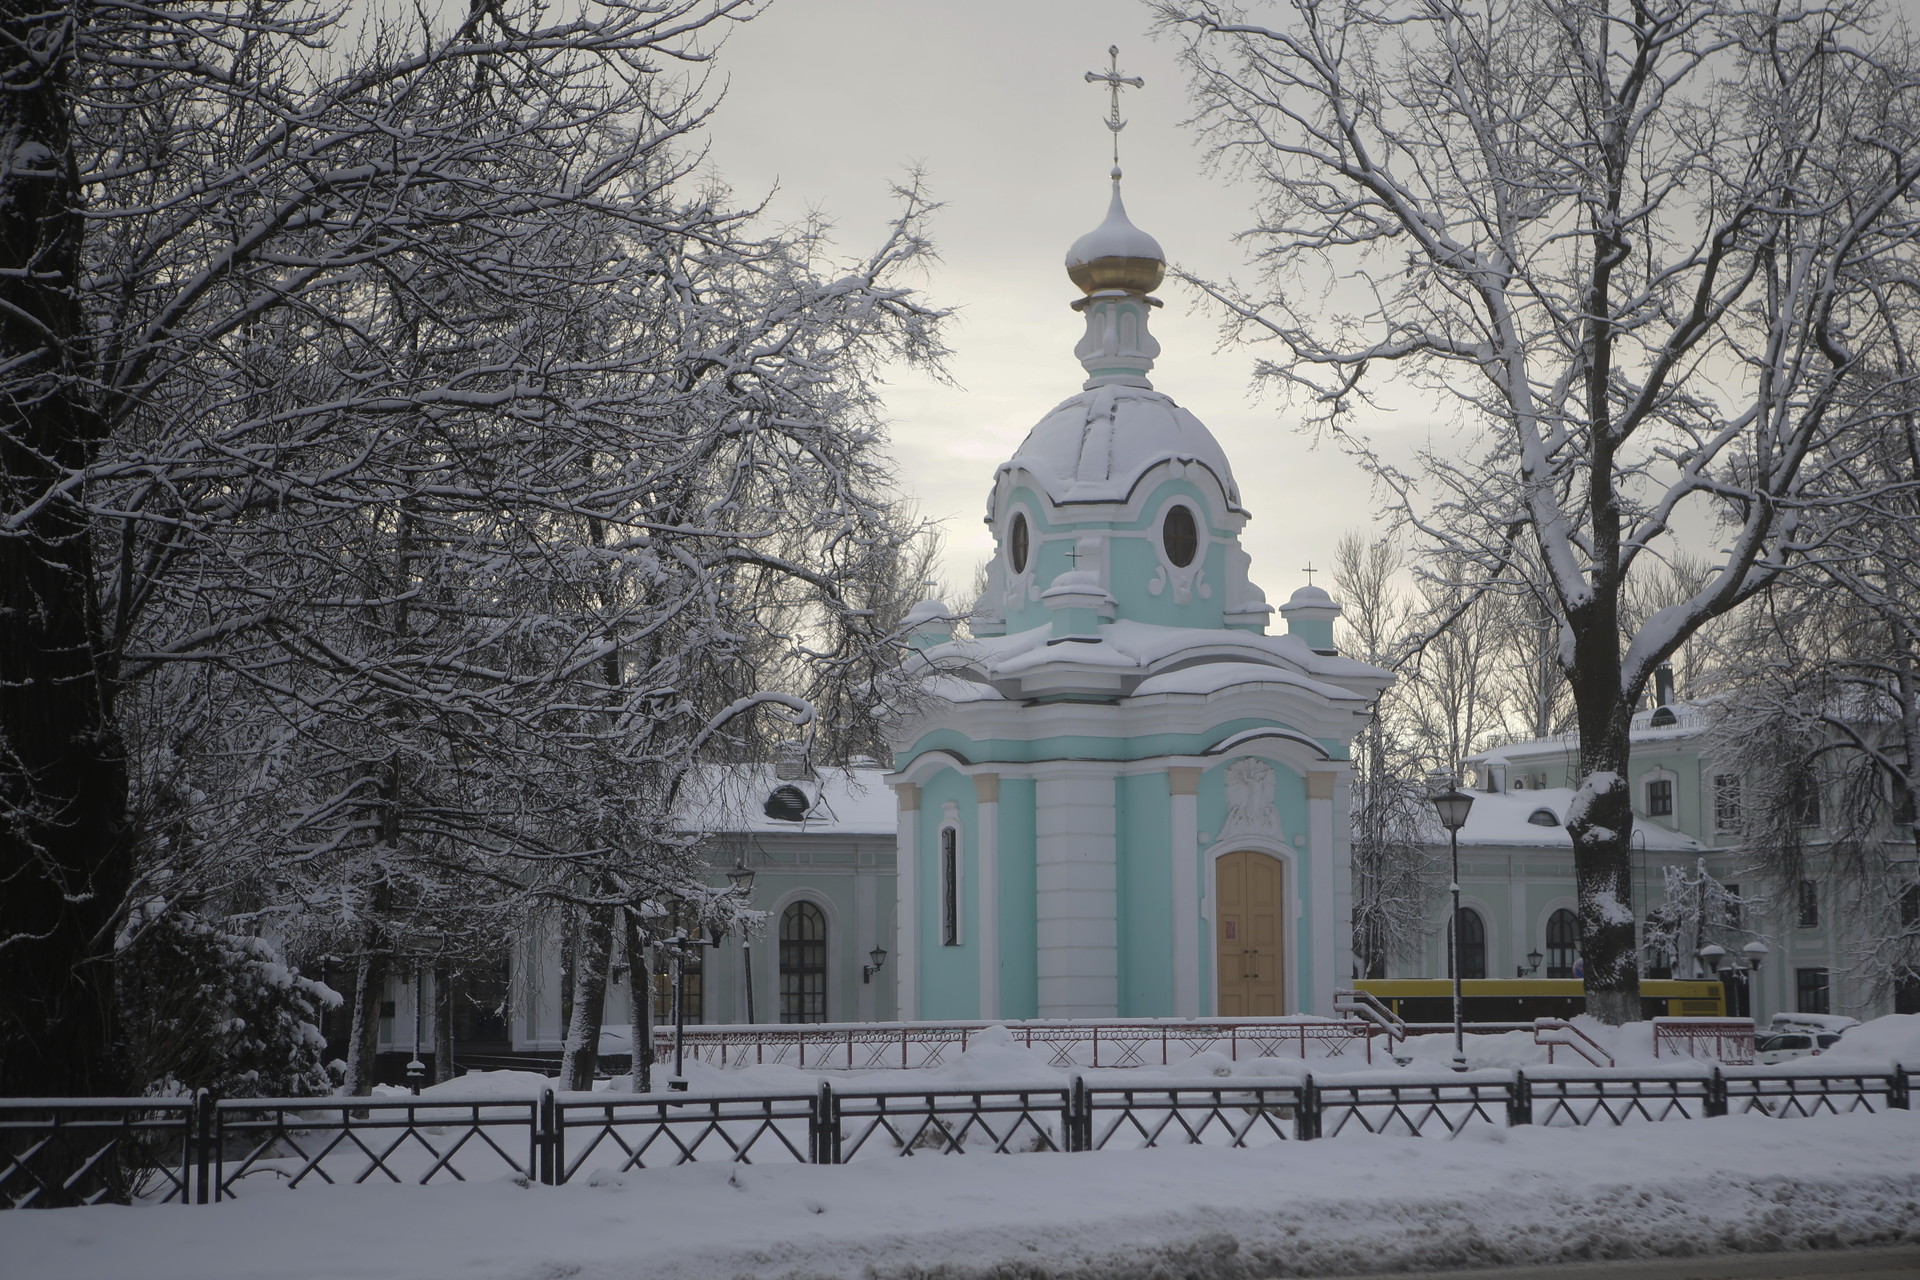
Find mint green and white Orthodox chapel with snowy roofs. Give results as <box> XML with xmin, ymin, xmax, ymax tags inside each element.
<box><xmin>887</xmin><ymin>175</ymin><xmax>1392</xmax><ymax>1019</ymax></box>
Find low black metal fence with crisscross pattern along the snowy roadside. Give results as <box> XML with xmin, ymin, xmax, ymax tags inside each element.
<box><xmin>0</xmin><ymin>1067</ymin><xmax>1912</xmax><ymax>1207</ymax></box>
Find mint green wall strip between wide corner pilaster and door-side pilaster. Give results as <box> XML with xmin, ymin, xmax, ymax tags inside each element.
<box><xmin>1116</xmin><ymin>771</ymin><xmax>1173</xmax><ymax>1017</ymax></box>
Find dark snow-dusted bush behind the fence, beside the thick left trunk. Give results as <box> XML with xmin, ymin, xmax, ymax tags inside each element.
<box><xmin>117</xmin><ymin>898</ymin><xmax>340</xmax><ymax>1098</ymax></box>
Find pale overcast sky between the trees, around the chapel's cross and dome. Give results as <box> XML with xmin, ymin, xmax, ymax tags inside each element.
<box><xmin>687</xmin><ymin>0</ymin><xmax>1427</xmax><ymax>603</ymax></box>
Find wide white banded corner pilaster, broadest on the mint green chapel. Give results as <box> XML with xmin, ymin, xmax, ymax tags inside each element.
<box><xmin>1035</xmin><ymin>771</ymin><xmax>1119</xmax><ymax>1017</ymax></box>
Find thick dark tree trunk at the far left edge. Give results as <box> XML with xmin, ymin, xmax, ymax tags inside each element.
<box><xmin>0</xmin><ymin>4</ymin><xmax>132</xmax><ymax>1096</ymax></box>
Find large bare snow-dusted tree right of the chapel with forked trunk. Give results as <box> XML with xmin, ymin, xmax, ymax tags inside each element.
<box><xmin>1160</xmin><ymin>0</ymin><xmax>1920</xmax><ymax>1023</ymax></box>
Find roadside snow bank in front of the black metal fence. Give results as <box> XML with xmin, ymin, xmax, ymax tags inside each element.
<box><xmin>0</xmin><ymin>1105</ymin><xmax>1920</xmax><ymax>1280</ymax></box>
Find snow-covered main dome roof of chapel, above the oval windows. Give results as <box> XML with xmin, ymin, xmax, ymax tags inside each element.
<box><xmin>1000</xmin><ymin>386</ymin><xmax>1240</xmax><ymax>510</ymax></box>
